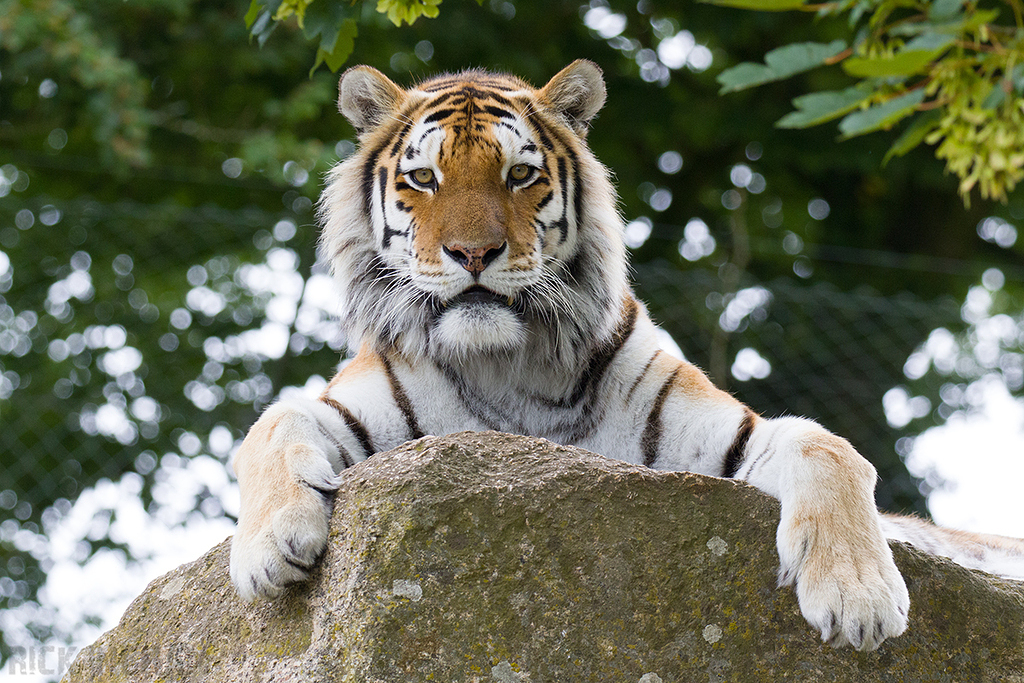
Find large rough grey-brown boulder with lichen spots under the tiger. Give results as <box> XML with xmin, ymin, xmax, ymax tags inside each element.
<box><xmin>66</xmin><ymin>433</ymin><xmax>1024</xmax><ymax>683</ymax></box>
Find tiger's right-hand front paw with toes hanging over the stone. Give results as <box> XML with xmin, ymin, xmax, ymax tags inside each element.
<box><xmin>777</xmin><ymin>517</ymin><xmax>910</xmax><ymax>651</ymax></box>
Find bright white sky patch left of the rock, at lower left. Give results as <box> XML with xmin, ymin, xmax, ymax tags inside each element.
<box><xmin>0</xmin><ymin>456</ymin><xmax>239</xmax><ymax>683</ymax></box>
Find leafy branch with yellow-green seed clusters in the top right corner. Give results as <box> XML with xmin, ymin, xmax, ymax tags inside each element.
<box><xmin>709</xmin><ymin>0</ymin><xmax>1024</xmax><ymax>204</ymax></box>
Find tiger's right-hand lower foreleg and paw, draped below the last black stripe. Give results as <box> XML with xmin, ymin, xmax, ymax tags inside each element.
<box><xmin>736</xmin><ymin>418</ymin><xmax>910</xmax><ymax>650</ymax></box>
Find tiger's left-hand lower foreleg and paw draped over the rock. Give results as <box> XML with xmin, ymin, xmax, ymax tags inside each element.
<box><xmin>230</xmin><ymin>400</ymin><xmax>344</xmax><ymax>600</ymax></box>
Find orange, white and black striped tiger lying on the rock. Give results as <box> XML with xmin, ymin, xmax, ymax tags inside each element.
<box><xmin>230</xmin><ymin>60</ymin><xmax>1024</xmax><ymax>651</ymax></box>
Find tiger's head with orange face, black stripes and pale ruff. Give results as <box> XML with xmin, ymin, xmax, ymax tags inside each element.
<box><xmin>319</xmin><ymin>60</ymin><xmax>628</xmax><ymax>360</ymax></box>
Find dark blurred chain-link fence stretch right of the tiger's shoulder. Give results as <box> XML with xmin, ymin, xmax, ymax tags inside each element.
<box><xmin>636</xmin><ymin>263</ymin><xmax>961</xmax><ymax>512</ymax></box>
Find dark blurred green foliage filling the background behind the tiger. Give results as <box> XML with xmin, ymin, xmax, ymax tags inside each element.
<box><xmin>0</xmin><ymin>0</ymin><xmax>1024</xmax><ymax>657</ymax></box>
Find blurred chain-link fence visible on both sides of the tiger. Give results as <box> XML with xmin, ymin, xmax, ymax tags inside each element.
<box><xmin>0</xmin><ymin>179</ymin><xmax>974</xmax><ymax>675</ymax></box>
